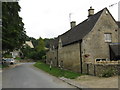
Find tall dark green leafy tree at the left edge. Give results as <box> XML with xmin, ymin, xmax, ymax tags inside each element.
<box><xmin>2</xmin><ymin>2</ymin><xmax>26</xmax><ymax>51</ymax></box>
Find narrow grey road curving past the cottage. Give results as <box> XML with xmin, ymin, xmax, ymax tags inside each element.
<box><xmin>2</xmin><ymin>63</ymin><xmax>75</xmax><ymax>88</ymax></box>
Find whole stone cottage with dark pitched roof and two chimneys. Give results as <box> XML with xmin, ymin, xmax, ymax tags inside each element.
<box><xmin>47</xmin><ymin>7</ymin><xmax>120</xmax><ymax>73</ymax></box>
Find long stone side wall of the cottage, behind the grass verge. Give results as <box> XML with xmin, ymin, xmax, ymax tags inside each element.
<box><xmin>58</xmin><ymin>43</ymin><xmax>81</xmax><ymax>72</ymax></box>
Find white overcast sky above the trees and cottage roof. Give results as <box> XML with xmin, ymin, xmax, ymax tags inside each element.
<box><xmin>19</xmin><ymin>0</ymin><xmax>120</xmax><ymax>39</ymax></box>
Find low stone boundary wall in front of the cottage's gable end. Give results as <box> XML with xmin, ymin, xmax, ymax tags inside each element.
<box><xmin>83</xmin><ymin>63</ymin><xmax>120</xmax><ymax>76</ymax></box>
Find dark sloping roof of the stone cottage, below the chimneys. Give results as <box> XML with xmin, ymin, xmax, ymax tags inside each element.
<box><xmin>52</xmin><ymin>8</ymin><xmax>106</xmax><ymax>48</ymax></box>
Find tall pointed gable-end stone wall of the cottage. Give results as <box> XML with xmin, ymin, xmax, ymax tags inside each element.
<box><xmin>82</xmin><ymin>10</ymin><xmax>118</xmax><ymax>63</ymax></box>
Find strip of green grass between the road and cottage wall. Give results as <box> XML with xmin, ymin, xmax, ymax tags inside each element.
<box><xmin>34</xmin><ymin>61</ymin><xmax>81</xmax><ymax>79</ymax></box>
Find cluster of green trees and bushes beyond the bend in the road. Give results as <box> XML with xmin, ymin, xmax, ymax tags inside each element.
<box><xmin>21</xmin><ymin>37</ymin><xmax>52</xmax><ymax>61</ymax></box>
